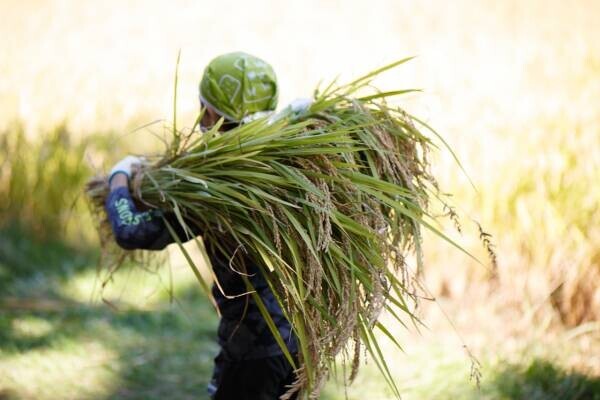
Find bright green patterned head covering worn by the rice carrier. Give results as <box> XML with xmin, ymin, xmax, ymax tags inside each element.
<box><xmin>200</xmin><ymin>52</ymin><xmax>277</xmax><ymax>122</ymax></box>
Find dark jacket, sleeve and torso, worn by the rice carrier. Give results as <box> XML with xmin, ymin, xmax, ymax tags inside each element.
<box><xmin>106</xmin><ymin>187</ymin><xmax>298</xmax><ymax>360</ymax></box>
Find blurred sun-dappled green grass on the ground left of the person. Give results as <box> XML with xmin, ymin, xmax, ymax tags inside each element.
<box><xmin>0</xmin><ymin>230</ymin><xmax>217</xmax><ymax>399</ymax></box>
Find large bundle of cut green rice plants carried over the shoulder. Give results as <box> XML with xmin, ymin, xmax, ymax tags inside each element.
<box><xmin>88</xmin><ymin>60</ymin><xmax>476</xmax><ymax>398</ymax></box>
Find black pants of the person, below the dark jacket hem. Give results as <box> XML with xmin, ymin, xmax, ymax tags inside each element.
<box><xmin>209</xmin><ymin>354</ymin><xmax>296</xmax><ymax>400</ymax></box>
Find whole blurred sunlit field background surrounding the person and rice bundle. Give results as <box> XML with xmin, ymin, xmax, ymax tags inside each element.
<box><xmin>0</xmin><ymin>0</ymin><xmax>600</xmax><ymax>400</ymax></box>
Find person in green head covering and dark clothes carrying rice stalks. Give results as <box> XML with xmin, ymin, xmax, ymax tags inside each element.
<box><xmin>106</xmin><ymin>53</ymin><xmax>298</xmax><ymax>400</ymax></box>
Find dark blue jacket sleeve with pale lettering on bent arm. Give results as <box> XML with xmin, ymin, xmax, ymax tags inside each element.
<box><xmin>105</xmin><ymin>187</ymin><xmax>200</xmax><ymax>250</ymax></box>
